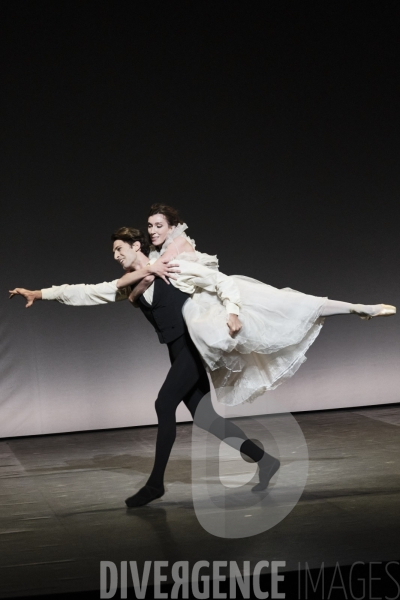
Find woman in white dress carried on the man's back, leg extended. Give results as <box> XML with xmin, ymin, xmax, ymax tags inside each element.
<box><xmin>117</xmin><ymin>204</ymin><xmax>396</xmax><ymax>405</ymax></box>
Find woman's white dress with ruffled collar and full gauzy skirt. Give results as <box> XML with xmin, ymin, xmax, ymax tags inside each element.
<box><xmin>150</xmin><ymin>224</ymin><xmax>326</xmax><ymax>405</ymax></box>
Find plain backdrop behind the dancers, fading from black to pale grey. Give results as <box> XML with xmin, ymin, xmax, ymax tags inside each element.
<box><xmin>0</xmin><ymin>2</ymin><xmax>400</xmax><ymax>437</ymax></box>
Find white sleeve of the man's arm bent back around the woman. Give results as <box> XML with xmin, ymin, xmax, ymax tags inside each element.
<box><xmin>171</xmin><ymin>259</ymin><xmax>242</xmax><ymax>315</ymax></box>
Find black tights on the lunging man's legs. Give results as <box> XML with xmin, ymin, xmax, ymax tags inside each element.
<box><xmin>147</xmin><ymin>332</ymin><xmax>264</xmax><ymax>488</ymax></box>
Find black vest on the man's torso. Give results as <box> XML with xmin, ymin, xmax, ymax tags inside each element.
<box><xmin>139</xmin><ymin>277</ymin><xmax>189</xmax><ymax>344</ymax></box>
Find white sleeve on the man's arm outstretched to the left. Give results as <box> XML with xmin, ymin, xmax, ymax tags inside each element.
<box><xmin>42</xmin><ymin>279</ymin><xmax>128</xmax><ymax>306</ymax></box>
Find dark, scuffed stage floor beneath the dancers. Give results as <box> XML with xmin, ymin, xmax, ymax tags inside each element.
<box><xmin>0</xmin><ymin>405</ymin><xmax>400</xmax><ymax>598</ymax></box>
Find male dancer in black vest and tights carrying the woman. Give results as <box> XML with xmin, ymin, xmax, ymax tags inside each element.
<box><xmin>10</xmin><ymin>227</ymin><xmax>280</xmax><ymax>508</ymax></box>
